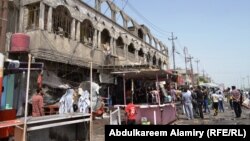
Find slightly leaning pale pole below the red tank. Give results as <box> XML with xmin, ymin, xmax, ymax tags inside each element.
<box><xmin>23</xmin><ymin>54</ymin><xmax>31</xmax><ymax>141</ymax></box>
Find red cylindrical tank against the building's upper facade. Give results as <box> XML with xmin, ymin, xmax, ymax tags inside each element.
<box><xmin>10</xmin><ymin>33</ymin><xmax>30</xmax><ymax>52</ymax></box>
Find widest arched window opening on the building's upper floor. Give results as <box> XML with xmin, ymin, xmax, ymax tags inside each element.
<box><xmin>52</xmin><ymin>6</ymin><xmax>73</xmax><ymax>38</ymax></box>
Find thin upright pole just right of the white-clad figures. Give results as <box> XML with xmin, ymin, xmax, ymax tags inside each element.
<box><xmin>89</xmin><ymin>61</ymin><xmax>93</xmax><ymax>141</ymax></box>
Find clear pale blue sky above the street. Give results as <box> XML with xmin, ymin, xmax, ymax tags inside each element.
<box><xmin>111</xmin><ymin>0</ymin><xmax>250</xmax><ymax>87</ymax></box>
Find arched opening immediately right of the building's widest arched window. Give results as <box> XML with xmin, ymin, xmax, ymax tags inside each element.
<box><xmin>80</xmin><ymin>19</ymin><xmax>94</xmax><ymax>43</ymax></box>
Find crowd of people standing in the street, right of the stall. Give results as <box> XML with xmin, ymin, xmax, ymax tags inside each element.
<box><xmin>180</xmin><ymin>86</ymin><xmax>248</xmax><ymax>120</ymax></box>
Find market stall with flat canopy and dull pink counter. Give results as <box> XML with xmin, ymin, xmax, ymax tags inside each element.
<box><xmin>112</xmin><ymin>69</ymin><xmax>177</xmax><ymax>125</ymax></box>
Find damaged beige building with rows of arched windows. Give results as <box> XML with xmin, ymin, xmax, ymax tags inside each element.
<box><xmin>1</xmin><ymin>0</ymin><xmax>169</xmax><ymax>104</ymax></box>
